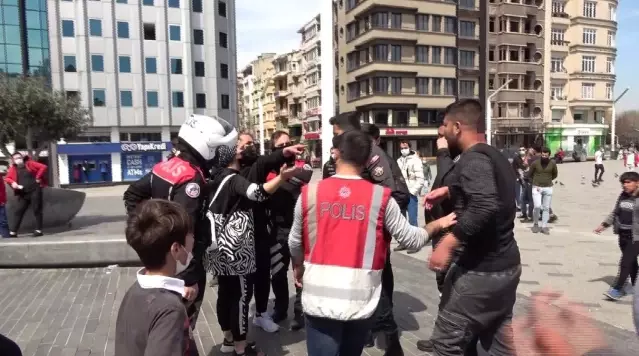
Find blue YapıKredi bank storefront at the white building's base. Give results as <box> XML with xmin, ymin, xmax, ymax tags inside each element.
<box><xmin>58</xmin><ymin>142</ymin><xmax>171</xmax><ymax>184</ymax></box>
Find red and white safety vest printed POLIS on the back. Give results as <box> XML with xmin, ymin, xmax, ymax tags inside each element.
<box><xmin>301</xmin><ymin>177</ymin><xmax>391</xmax><ymax>321</ymax></box>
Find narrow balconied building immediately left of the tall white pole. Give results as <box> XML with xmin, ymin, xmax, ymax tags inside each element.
<box><xmin>298</xmin><ymin>15</ymin><xmax>322</xmax><ymax>160</ymax></box>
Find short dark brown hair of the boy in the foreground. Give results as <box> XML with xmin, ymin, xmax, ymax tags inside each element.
<box><xmin>125</xmin><ymin>199</ymin><xmax>193</xmax><ymax>270</ymax></box>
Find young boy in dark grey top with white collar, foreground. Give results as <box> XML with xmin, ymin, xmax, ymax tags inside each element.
<box><xmin>115</xmin><ymin>199</ymin><xmax>196</xmax><ymax>356</ymax></box>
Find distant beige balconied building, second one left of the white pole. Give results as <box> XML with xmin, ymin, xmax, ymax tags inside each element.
<box><xmin>273</xmin><ymin>51</ymin><xmax>304</xmax><ymax>140</ymax></box>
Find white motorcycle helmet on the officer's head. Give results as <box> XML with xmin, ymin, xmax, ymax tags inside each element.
<box><xmin>178</xmin><ymin>114</ymin><xmax>238</xmax><ymax>161</ymax></box>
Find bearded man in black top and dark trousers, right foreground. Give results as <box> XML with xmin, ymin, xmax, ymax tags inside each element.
<box><xmin>426</xmin><ymin>99</ymin><xmax>521</xmax><ymax>356</ymax></box>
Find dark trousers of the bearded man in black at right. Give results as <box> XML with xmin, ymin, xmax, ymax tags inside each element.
<box><xmin>431</xmin><ymin>264</ymin><xmax>521</xmax><ymax>356</ymax></box>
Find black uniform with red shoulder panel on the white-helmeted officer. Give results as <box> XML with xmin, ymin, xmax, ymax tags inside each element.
<box><xmin>124</xmin><ymin>156</ymin><xmax>211</xmax><ymax>326</ymax></box>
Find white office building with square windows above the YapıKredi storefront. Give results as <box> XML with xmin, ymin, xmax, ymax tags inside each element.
<box><xmin>33</xmin><ymin>0</ymin><xmax>237</xmax><ymax>184</ymax></box>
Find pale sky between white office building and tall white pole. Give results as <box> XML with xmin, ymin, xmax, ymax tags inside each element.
<box><xmin>235</xmin><ymin>0</ymin><xmax>327</xmax><ymax>70</ymax></box>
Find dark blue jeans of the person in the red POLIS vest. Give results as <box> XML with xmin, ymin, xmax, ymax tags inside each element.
<box><xmin>306</xmin><ymin>315</ymin><xmax>372</xmax><ymax>356</ymax></box>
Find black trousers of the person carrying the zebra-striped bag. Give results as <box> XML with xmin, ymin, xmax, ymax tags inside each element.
<box><xmin>216</xmin><ymin>275</ymin><xmax>254</xmax><ymax>341</ymax></box>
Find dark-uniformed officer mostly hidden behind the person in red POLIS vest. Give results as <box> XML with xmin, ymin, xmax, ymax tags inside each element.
<box><xmin>329</xmin><ymin>112</ymin><xmax>410</xmax><ymax>356</ymax></box>
